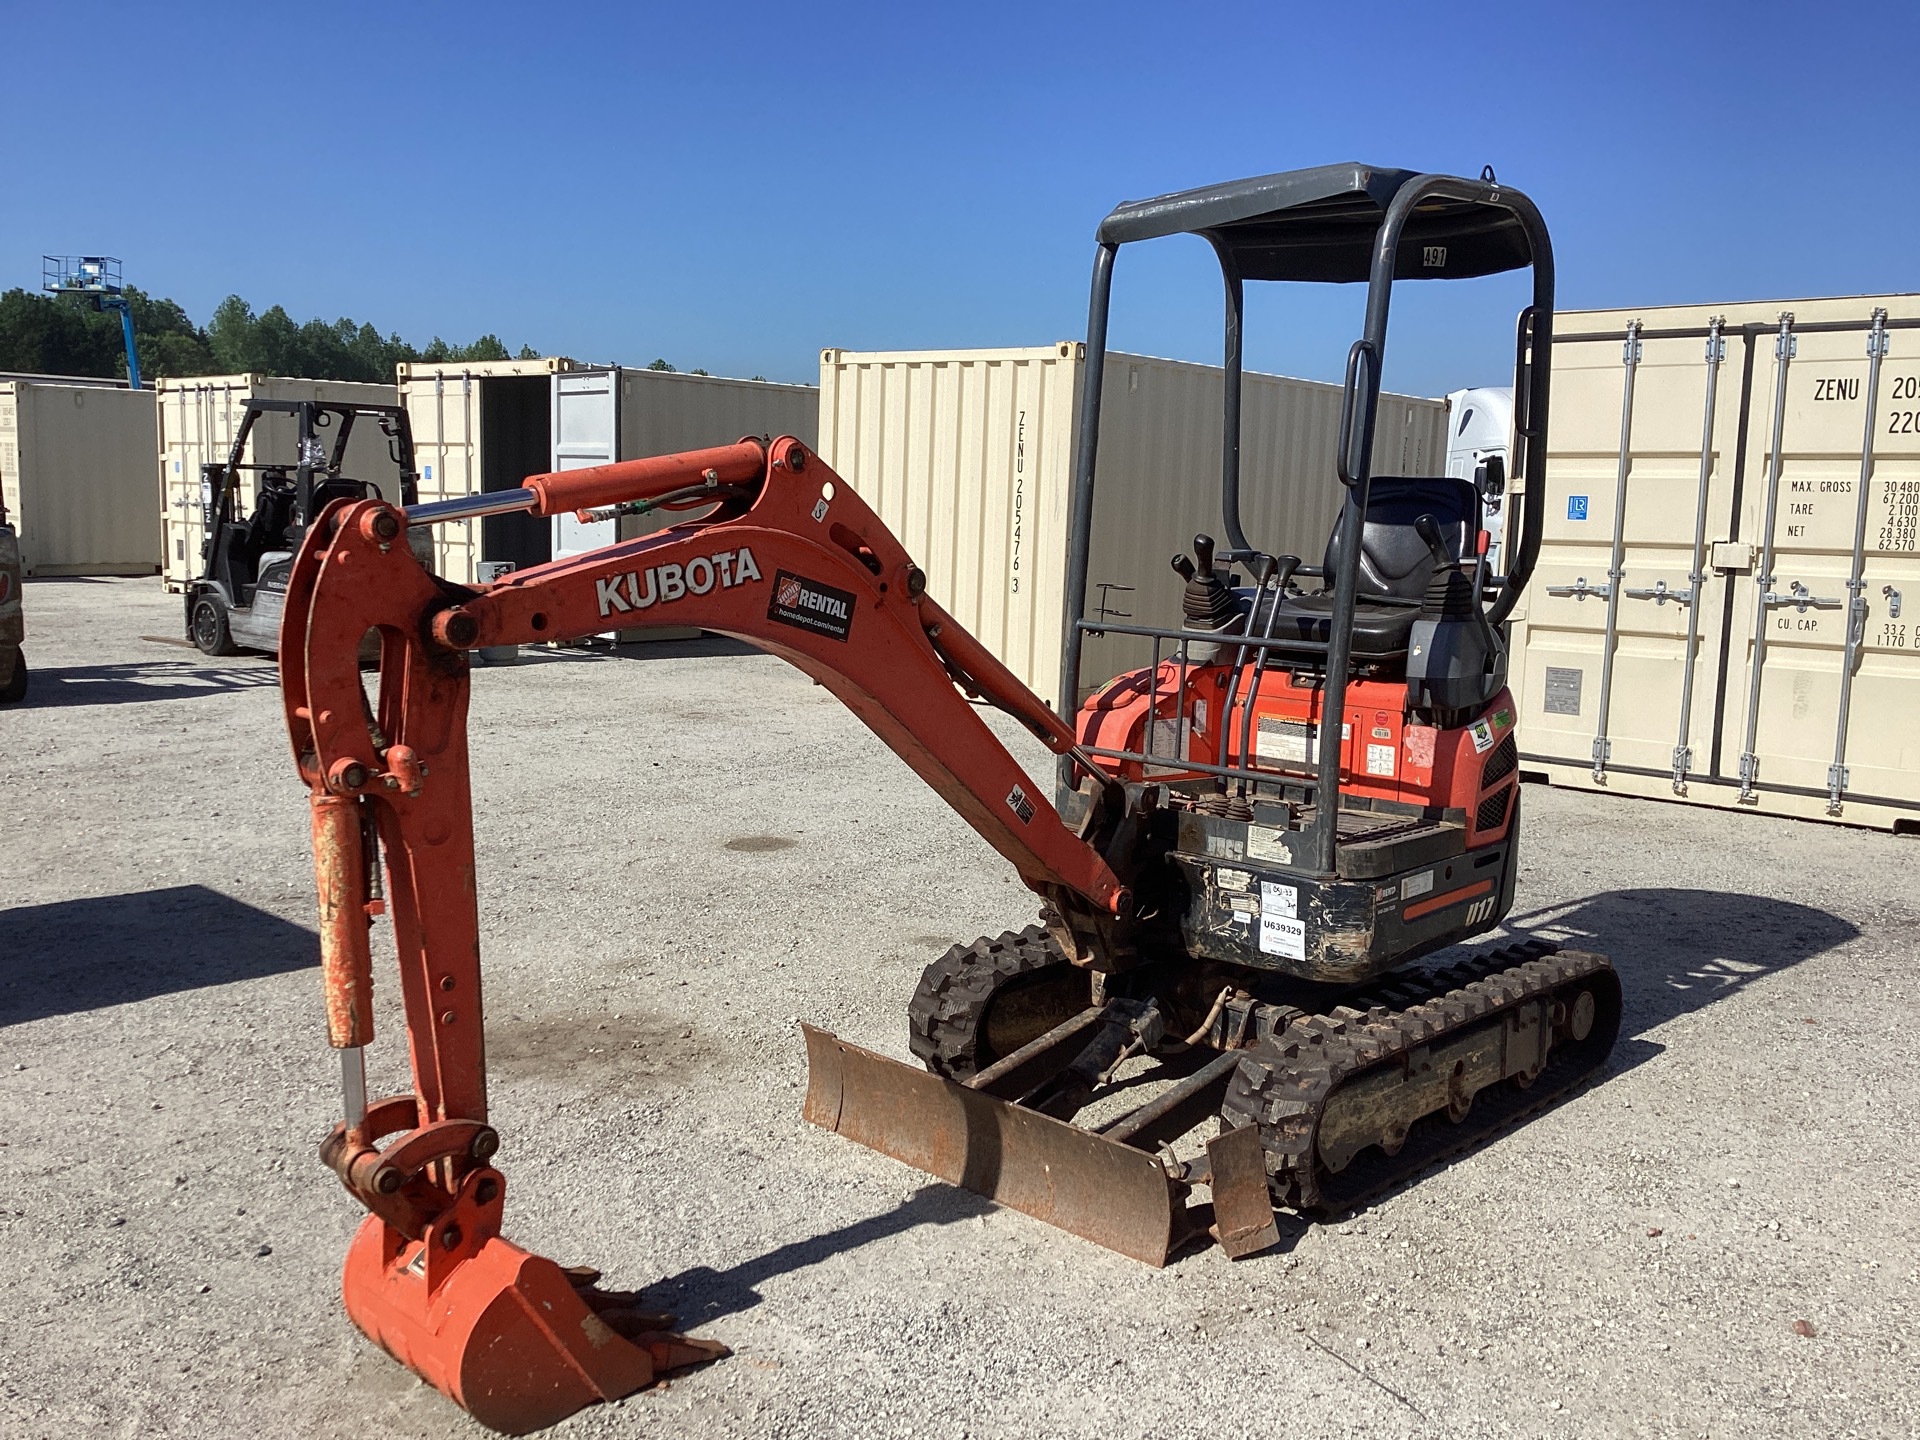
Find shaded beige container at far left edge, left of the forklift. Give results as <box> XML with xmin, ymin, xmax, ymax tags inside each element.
<box><xmin>0</xmin><ymin>378</ymin><xmax>159</xmax><ymax>576</ymax></box>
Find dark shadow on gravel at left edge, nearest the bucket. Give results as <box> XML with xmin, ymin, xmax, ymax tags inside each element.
<box><xmin>0</xmin><ymin>885</ymin><xmax>321</xmax><ymax>1025</ymax></box>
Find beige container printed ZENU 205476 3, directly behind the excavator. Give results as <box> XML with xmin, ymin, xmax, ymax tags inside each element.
<box><xmin>820</xmin><ymin>340</ymin><xmax>1446</xmax><ymax>705</ymax></box>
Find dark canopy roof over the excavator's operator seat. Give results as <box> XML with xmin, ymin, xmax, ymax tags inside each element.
<box><xmin>1100</xmin><ymin>163</ymin><xmax>1532</xmax><ymax>282</ymax></box>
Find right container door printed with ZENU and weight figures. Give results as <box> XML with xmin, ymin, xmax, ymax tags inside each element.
<box><xmin>1722</xmin><ymin>301</ymin><xmax>1920</xmax><ymax>824</ymax></box>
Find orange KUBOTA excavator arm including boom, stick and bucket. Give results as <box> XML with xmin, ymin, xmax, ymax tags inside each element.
<box><xmin>280</xmin><ymin>438</ymin><xmax>1133</xmax><ymax>1432</ymax></box>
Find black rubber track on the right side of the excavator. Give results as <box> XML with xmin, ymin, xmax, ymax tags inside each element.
<box><xmin>1221</xmin><ymin>941</ymin><xmax>1620</xmax><ymax>1213</ymax></box>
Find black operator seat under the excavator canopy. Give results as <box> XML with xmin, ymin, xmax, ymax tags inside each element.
<box><xmin>1248</xmin><ymin>474</ymin><xmax>1480</xmax><ymax>666</ymax></box>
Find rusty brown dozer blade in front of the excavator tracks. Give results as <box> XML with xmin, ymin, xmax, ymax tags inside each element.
<box><xmin>801</xmin><ymin>1025</ymin><xmax>1190</xmax><ymax>1265</ymax></box>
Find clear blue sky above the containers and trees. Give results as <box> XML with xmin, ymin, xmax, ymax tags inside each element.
<box><xmin>0</xmin><ymin>0</ymin><xmax>1920</xmax><ymax>394</ymax></box>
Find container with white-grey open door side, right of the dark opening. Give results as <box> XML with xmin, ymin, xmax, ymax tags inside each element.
<box><xmin>547</xmin><ymin>369</ymin><xmax>820</xmax><ymax>641</ymax></box>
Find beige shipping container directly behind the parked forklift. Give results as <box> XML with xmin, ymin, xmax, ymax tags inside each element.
<box><xmin>162</xmin><ymin>374</ymin><xmax>399</xmax><ymax>591</ymax></box>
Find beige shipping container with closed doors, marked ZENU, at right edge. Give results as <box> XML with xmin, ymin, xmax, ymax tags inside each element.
<box><xmin>1513</xmin><ymin>296</ymin><xmax>1920</xmax><ymax>829</ymax></box>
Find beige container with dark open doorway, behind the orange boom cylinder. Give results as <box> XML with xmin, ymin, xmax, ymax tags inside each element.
<box><xmin>397</xmin><ymin>355</ymin><xmax>580</xmax><ymax>586</ymax></box>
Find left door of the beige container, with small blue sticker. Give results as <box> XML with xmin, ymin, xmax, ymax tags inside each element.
<box><xmin>1513</xmin><ymin>314</ymin><xmax>1740</xmax><ymax>793</ymax></box>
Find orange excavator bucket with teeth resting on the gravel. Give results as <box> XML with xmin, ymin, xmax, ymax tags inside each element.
<box><xmin>342</xmin><ymin>1215</ymin><xmax>728</xmax><ymax>1434</ymax></box>
